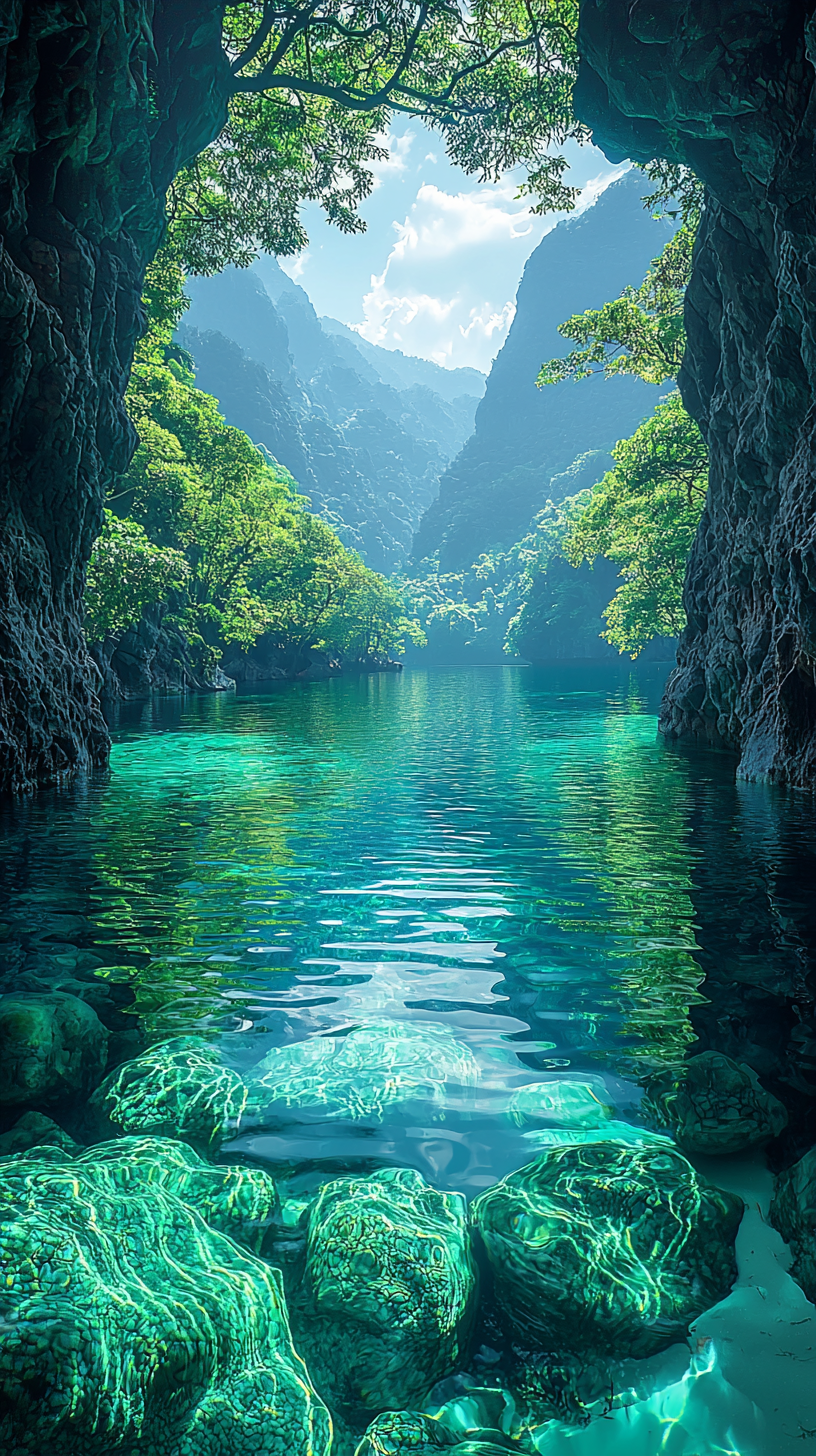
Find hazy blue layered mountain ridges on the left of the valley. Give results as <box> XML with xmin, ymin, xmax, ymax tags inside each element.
<box><xmin>178</xmin><ymin>258</ymin><xmax>484</xmax><ymax>572</ymax></box>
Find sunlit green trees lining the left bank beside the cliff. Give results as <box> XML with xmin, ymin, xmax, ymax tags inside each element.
<box><xmin>89</xmin><ymin>252</ymin><xmax>423</xmax><ymax>660</ymax></box>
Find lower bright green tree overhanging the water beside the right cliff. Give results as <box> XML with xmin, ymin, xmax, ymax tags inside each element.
<box><xmin>564</xmin><ymin>392</ymin><xmax>708</xmax><ymax>657</ymax></box>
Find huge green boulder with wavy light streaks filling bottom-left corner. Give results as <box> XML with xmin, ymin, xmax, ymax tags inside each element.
<box><xmin>0</xmin><ymin>1149</ymin><xmax>331</xmax><ymax>1456</ymax></box>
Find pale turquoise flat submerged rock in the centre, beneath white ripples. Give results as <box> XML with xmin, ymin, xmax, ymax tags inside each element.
<box><xmin>252</xmin><ymin>1021</ymin><xmax>479</xmax><ymax>1123</ymax></box>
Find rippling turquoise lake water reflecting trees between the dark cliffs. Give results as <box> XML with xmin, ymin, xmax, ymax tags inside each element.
<box><xmin>0</xmin><ymin>665</ymin><xmax>816</xmax><ymax>1456</ymax></box>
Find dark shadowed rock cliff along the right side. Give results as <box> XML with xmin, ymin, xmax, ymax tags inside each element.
<box><xmin>577</xmin><ymin>0</ymin><xmax>816</xmax><ymax>786</ymax></box>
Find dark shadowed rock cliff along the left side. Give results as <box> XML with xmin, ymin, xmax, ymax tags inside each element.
<box><xmin>0</xmin><ymin>0</ymin><xmax>229</xmax><ymax>791</ymax></box>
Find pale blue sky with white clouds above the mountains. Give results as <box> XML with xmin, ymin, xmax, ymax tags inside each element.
<box><xmin>280</xmin><ymin>118</ymin><xmax>625</xmax><ymax>371</ymax></box>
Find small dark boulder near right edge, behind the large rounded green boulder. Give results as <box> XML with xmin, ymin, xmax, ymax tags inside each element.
<box><xmin>643</xmin><ymin>1051</ymin><xmax>788</xmax><ymax>1156</ymax></box>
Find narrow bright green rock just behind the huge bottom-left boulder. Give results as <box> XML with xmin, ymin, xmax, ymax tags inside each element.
<box><xmin>74</xmin><ymin>1137</ymin><xmax>280</xmax><ymax>1254</ymax></box>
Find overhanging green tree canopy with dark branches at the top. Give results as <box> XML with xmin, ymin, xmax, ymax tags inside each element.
<box><xmin>169</xmin><ymin>0</ymin><xmax>587</xmax><ymax>272</ymax></box>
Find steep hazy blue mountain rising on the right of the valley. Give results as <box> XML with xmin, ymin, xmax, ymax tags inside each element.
<box><xmin>414</xmin><ymin>170</ymin><xmax>673</xmax><ymax>571</ymax></box>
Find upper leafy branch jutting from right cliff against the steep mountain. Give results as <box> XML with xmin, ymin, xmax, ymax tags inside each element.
<box><xmin>536</xmin><ymin>226</ymin><xmax>694</xmax><ymax>387</ymax></box>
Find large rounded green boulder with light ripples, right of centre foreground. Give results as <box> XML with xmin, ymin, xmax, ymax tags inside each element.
<box><xmin>472</xmin><ymin>1142</ymin><xmax>743</xmax><ymax>1356</ymax></box>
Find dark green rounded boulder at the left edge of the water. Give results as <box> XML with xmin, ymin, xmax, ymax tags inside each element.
<box><xmin>0</xmin><ymin>992</ymin><xmax>108</xmax><ymax>1107</ymax></box>
